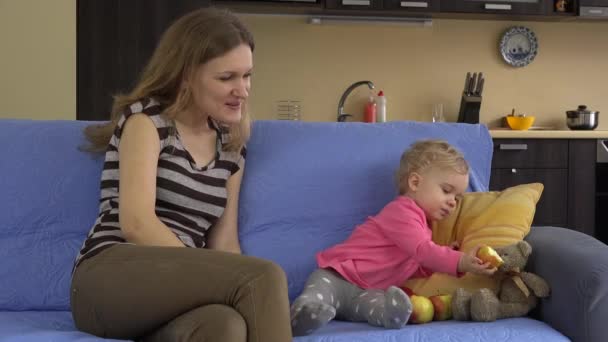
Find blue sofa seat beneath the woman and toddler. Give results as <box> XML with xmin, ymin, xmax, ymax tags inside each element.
<box><xmin>0</xmin><ymin>311</ymin><xmax>569</xmax><ymax>342</ymax></box>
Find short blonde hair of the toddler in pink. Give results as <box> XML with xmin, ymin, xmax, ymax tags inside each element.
<box><xmin>396</xmin><ymin>140</ymin><xmax>469</xmax><ymax>194</ymax></box>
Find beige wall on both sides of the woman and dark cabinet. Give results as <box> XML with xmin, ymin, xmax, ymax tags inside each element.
<box><xmin>0</xmin><ymin>0</ymin><xmax>608</xmax><ymax>129</ymax></box>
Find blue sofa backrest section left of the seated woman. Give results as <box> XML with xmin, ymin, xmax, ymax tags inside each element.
<box><xmin>0</xmin><ymin>120</ymin><xmax>103</xmax><ymax>310</ymax></box>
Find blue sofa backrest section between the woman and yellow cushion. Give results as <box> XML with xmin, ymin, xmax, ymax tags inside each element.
<box><xmin>239</xmin><ymin>121</ymin><xmax>492</xmax><ymax>299</ymax></box>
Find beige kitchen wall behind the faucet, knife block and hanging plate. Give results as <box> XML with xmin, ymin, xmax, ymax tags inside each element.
<box><xmin>245</xmin><ymin>16</ymin><xmax>608</xmax><ymax>129</ymax></box>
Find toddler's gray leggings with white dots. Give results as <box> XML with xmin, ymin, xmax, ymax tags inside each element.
<box><xmin>291</xmin><ymin>269</ymin><xmax>412</xmax><ymax>336</ymax></box>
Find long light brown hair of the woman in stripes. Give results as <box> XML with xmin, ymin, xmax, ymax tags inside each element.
<box><xmin>84</xmin><ymin>8</ymin><xmax>255</xmax><ymax>151</ymax></box>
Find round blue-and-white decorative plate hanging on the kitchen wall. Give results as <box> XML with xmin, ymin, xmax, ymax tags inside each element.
<box><xmin>500</xmin><ymin>26</ymin><xmax>538</xmax><ymax>67</ymax></box>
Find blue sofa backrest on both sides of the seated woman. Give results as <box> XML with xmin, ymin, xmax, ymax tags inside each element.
<box><xmin>0</xmin><ymin>120</ymin><xmax>492</xmax><ymax>310</ymax></box>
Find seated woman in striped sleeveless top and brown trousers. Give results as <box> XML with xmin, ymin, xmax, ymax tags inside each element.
<box><xmin>71</xmin><ymin>9</ymin><xmax>291</xmax><ymax>342</ymax></box>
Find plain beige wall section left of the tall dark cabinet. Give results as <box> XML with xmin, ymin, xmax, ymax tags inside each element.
<box><xmin>0</xmin><ymin>0</ymin><xmax>76</xmax><ymax>119</ymax></box>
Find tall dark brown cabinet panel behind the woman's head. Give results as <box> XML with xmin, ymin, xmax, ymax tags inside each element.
<box><xmin>76</xmin><ymin>0</ymin><xmax>210</xmax><ymax>120</ymax></box>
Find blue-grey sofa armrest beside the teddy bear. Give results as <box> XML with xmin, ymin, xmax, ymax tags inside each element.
<box><xmin>526</xmin><ymin>227</ymin><xmax>608</xmax><ymax>342</ymax></box>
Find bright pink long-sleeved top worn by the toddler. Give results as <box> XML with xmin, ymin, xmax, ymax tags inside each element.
<box><xmin>317</xmin><ymin>196</ymin><xmax>462</xmax><ymax>290</ymax></box>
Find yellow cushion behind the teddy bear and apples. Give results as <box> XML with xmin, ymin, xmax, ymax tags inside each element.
<box><xmin>405</xmin><ymin>183</ymin><xmax>544</xmax><ymax>296</ymax></box>
